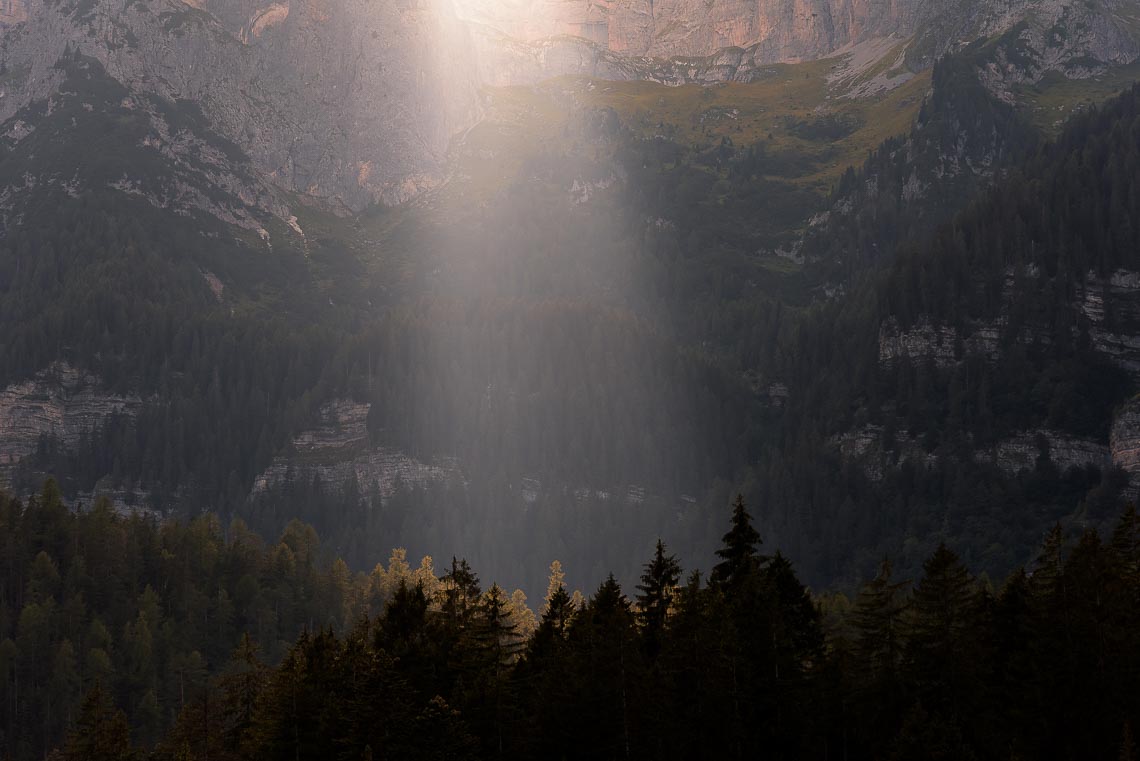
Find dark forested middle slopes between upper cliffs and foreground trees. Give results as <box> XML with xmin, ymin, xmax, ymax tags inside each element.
<box><xmin>13</xmin><ymin>46</ymin><xmax>1135</xmax><ymax>591</ymax></box>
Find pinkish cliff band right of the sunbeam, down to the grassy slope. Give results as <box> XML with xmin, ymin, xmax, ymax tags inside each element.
<box><xmin>458</xmin><ymin>0</ymin><xmax>1140</xmax><ymax>88</ymax></box>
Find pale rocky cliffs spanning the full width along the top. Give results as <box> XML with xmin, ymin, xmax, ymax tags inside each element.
<box><xmin>0</xmin><ymin>0</ymin><xmax>1140</xmax><ymax>210</ymax></box>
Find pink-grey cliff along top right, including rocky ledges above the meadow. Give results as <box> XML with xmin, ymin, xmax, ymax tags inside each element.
<box><xmin>459</xmin><ymin>0</ymin><xmax>1137</xmax><ymax>81</ymax></box>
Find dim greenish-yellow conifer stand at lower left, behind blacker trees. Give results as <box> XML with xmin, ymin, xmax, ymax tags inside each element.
<box><xmin>0</xmin><ymin>481</ymin><xmax>396</xmax><ymax>759</ymax></box>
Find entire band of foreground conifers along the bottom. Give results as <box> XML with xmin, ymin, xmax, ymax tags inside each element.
<box><xmin>0</xmin><ymin>484</ymin><xmax>1140</xmax><ymax>761</ymax></box>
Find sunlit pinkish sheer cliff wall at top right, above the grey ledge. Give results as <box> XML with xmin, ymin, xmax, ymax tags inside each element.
<box><xmin>459</xmin><ymin>0</ymin><xmax>1134</xmax><ymax>63</ymax></box>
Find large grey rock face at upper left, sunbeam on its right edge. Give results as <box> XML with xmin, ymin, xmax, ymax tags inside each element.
<box><xmin>0</xmin><ymin>0</ymin><xmax>479</xmax><ymax>210</ymax></box>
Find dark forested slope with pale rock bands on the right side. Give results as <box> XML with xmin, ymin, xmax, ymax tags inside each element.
<box><xmin>757</xmin><ymin>82</ymin><xmax>1140</xmax><ymax>575</ymax></box>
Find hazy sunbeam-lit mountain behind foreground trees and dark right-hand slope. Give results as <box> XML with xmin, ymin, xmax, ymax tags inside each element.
<box><xmin>0</xmin><ymin>0</ymin><xmax>1138</xmax><ymax>584</ymax></box>
